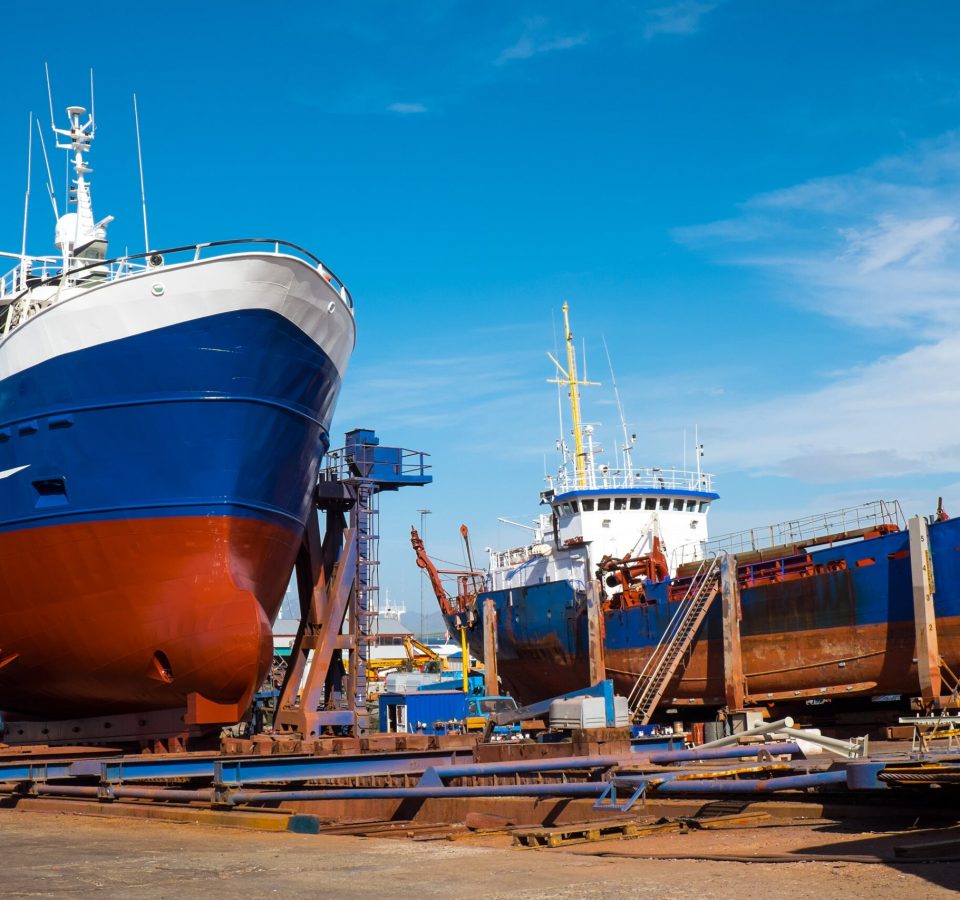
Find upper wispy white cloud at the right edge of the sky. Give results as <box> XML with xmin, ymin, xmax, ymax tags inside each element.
<box><xmin>674</xmin><ymin>133</ymin><xmax>960</xmax><ymax>340</ymax></box>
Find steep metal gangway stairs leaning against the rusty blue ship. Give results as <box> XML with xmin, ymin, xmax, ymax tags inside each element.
<box><xmin>628</xmin><ymin>556</ymin><xmax>720</xmax><ymax>725</ymax></box>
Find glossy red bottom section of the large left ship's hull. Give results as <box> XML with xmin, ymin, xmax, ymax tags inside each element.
<box><xmin>0</xmin><ymin>516</ymin><xmax>301</xmax><ymax>721</ymax></box>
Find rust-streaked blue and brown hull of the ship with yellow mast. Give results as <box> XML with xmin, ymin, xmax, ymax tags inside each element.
<box><xmin>450</xmin><ymin>519</ymin><xmax>960</xmax><ymax>706</ymax></box>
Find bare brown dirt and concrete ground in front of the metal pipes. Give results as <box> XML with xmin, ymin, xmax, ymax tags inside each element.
<box><xmin>0</xmin><ymin>810</ymin><xmax>960</xmax><ymax>900</ymax></box>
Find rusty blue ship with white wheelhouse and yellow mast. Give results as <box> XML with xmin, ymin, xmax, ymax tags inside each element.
<box><xmin>446</xmin><ymin>307</ymin><xmax>960</xmax><ymax>720</ymax></box>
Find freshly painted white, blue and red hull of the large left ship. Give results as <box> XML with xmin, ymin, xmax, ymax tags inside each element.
<box><xmin>0</xmin><ymin>254</ymin><xmax>354</xmax><ymax>719</ymax></box>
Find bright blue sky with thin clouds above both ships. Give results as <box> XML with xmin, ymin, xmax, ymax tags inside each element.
<box><xmin>0</xmin><ymin>0</ymin><xmax>960</xmax><ymax>632</ymax></box>
